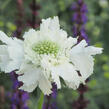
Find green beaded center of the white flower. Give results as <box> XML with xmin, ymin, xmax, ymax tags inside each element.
<box><xmin>33</xmin><ymin>41</ymin><xmax>59</xmax><ymax>56</ymax></box>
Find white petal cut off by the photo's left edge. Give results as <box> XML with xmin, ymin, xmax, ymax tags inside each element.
<box><xmin>0</xmin><ymin>31</ymin><xmax>24</xmax><ymax>73</ymax></box>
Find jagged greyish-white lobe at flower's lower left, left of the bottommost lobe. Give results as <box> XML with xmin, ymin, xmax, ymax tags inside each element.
<box><xmin>16</xmin><ymin>62</ymin><xmax>40</xmax><ymax>92</ymax></box>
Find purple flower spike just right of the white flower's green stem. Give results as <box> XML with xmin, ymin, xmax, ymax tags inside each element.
<box><xmin>43</xmin><ymin>83</ymin><xmax>58</xmax><ymax>109</ymax></box>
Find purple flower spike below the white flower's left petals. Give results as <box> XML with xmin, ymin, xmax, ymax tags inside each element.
<box><xmin>11</xmin><ymin>72</ymin><xmax>29</xmax><ymax>109</ymax></box>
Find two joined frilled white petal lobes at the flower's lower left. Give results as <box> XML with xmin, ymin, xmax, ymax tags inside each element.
<box><xmin>16</xmin><ymin>62</ymin><xmax>52</xmax><ymax>95</ymax></box>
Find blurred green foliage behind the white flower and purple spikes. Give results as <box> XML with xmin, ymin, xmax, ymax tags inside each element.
<box><xmin>0</xmin><ymin>0</ymin><xmax>109</xmax><ymax>109</ymax></box>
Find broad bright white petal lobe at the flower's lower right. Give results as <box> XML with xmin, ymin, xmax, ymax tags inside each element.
<box><xmin>51</xmin><ymin>62</ymin><xmax>81</xmax><ymax>89</ymax></box>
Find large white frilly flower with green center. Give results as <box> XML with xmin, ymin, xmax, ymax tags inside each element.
<box><xmin>0</xmin><ymin>17</ymin><xmax>102</xmax><ymax>95</ymax></box>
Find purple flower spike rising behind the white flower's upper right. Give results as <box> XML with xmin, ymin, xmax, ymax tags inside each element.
<box><xmin>71</xmin><ymin>0</ymin><xmax>89</xmax><ymax>43</ymax></box>
